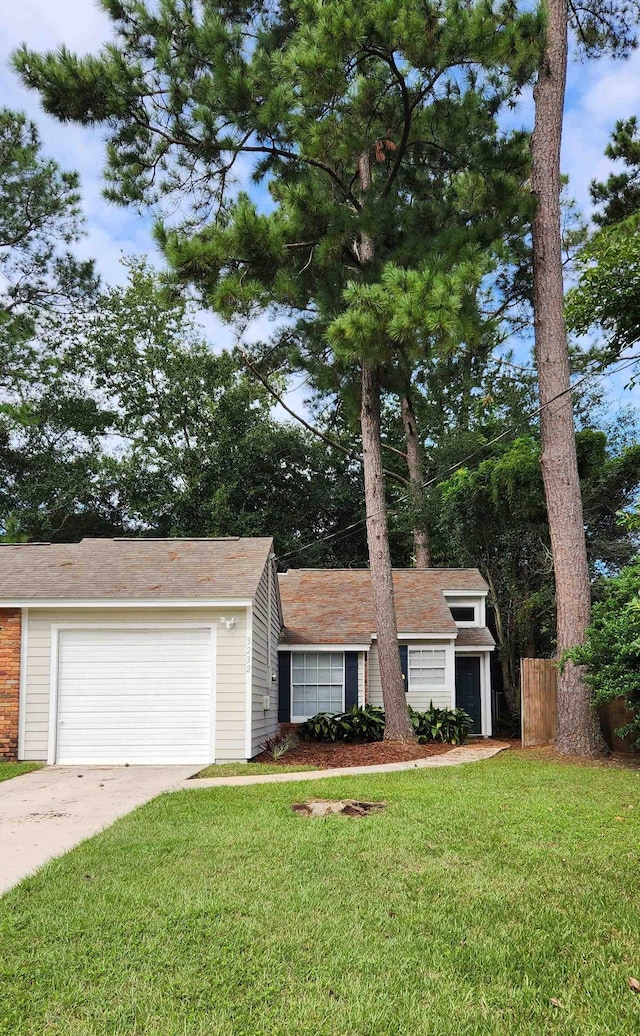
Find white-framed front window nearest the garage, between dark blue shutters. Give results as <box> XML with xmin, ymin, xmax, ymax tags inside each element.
<box><xmin>291</xmin><ymin>651</ymin><xmax>345</xmax><ymax>723</ymax></box>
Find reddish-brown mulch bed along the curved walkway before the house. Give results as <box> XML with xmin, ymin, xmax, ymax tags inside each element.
<box><xmin>249</xmin><ymin>741</ymin><xmax>486</xmax><ymax>770</ymax></box>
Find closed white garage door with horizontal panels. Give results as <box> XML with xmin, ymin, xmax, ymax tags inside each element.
<box><xmin>57</xmin><ymin>629</ymin><xmax>212</xmax><ymax>765</ymax></box>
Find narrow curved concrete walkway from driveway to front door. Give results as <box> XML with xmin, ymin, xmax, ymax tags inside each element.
<box><xmin>184</xmin><ymin>741</ymin><xmax>510</xmax><ymax>790</ymax></box>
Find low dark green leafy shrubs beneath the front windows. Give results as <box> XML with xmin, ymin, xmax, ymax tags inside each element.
<box><xmin>297</xmin><ymin>702</ymin><xmax>472</xmax><ymax>745</ymax></box>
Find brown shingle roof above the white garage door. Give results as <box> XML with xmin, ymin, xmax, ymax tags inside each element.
<box><xmin>0</xmin><ymin>537</ymin><xmax>272</xmax><ymax>601</ymax></box>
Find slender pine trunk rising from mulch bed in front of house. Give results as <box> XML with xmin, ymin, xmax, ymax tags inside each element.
<box><xmin>360</xmin><ymin>363</ymin><xmax>414</xmax><ymax>741</ymax></box>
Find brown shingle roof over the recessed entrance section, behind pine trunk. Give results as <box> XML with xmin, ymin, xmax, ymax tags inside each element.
<box><xmin>279</xmin><ymin>569</ymin><xmax>487</xmax><ymax>644</ymax></box>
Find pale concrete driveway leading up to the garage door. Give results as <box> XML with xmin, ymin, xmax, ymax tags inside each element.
<box><xmin>0</xmin><ymin>762</ymin><xmax>198</xmax><ymax>895</ymax></box>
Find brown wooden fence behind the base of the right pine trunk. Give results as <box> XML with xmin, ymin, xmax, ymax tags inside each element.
<box><xmin>520</xmin><ymin>658</ymin><xmax>636</xmax><ymax>753</ymax></box>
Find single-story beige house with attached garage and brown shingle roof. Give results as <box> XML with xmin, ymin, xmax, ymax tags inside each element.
<box><xmin>0</xmin><ymin>538</ymin><xmax>494</xmax><ymax>765</ymax></box>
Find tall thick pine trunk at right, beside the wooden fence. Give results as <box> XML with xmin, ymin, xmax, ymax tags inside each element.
<box><xmin>531</xmin><ymin>0</ymin><xmax>603</xmax><ymax>755</ymax></box>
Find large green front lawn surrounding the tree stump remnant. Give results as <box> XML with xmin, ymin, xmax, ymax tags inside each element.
<box><xmin>0</xmin><ymin>752</ymin><xmax>640</xmax><ymax>1036</ymax></box>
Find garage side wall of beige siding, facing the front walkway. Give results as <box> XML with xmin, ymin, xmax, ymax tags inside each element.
<box><xmin>248</xmin><ymin>563</ymin><xmax>280</xmax><ymax>757</ymax></box>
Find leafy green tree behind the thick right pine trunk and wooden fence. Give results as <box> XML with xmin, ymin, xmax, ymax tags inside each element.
<box><xmin>433</xmin><ymin>428</ymin><xmax>640</xmax><ymax>714</ymax></box>
